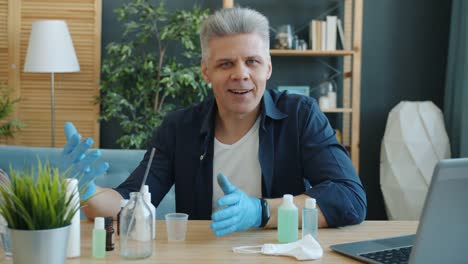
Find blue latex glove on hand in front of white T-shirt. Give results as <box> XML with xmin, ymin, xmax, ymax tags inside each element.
<box><xmin>210</xmin><ymin>173</ymin><xmax>262</xmax><ymax>236</ymax></box>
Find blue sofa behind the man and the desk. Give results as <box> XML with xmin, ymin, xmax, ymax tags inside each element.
<box><xmin>0</xmin><ymin>145</ymin><xmax>175</xmax><ymax>219</ymax></box>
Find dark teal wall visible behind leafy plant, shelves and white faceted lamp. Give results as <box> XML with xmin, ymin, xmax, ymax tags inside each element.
<box><xmin>101</xmin><ymin>0</ymin><xmax>451</xmax><ymax>219</ymax></box>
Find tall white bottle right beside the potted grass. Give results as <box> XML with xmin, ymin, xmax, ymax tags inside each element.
<box><xmin>67</xmin><ymin>179</ymin><xmax>81</xmax><ymax>258</ymax></box>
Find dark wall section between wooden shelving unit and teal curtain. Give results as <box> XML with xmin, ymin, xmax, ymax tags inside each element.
<box><xmin>360</xmin><ymin>0</ymin><xmax>451</xmax><ymax>219</ymax></box>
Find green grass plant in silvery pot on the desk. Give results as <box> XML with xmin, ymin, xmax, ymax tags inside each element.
<box><xmin>0</xmin><ymin>161</ymin><xmax>80</xmax><ymax>264</ymax></box>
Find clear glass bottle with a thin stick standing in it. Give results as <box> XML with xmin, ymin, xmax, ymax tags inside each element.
<box><xmin>120</xmin><ymin>192</ymin><xmax>153</xmax><ymax>259</ymax></box>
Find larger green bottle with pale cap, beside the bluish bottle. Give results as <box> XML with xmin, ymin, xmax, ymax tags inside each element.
<box><xmin>278</xmin><ymin>194</ymin><xmax>299</xmax><ymax>243</ymax></box>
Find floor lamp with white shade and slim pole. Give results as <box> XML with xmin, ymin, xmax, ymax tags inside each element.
<box><xmin>24</xmin><ymin>20</ymin><xmax>80</xmax><ymax>147</ymax></box>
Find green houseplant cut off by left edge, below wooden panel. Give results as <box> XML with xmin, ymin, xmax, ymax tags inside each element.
<box><xmin>0</xmin><ymin>83</ymin><xmax>24</xmax><ymax>139</ymax></box>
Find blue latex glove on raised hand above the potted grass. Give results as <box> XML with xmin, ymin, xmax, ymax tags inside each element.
<box><xmin>59</xmin><ymin>122</ymin><xmax>109</xmax><ymax>200</ymax></box>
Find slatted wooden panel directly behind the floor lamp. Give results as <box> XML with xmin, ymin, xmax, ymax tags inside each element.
<box><xmin>0</xmin><ymin>0</ymin><xmax>102</xmax><ymax>147</ymax></box>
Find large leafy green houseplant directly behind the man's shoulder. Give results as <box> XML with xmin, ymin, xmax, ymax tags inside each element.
<box><xmin>99</xmin><ymin>0</ymin><xmax>209</xmax><ymax>148</ymax></box>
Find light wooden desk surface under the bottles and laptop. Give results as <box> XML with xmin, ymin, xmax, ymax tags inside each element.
<box><xmin>6</xmin><ymin>221</ymin><xmax>418</xmax><ymax>264</ymax></box>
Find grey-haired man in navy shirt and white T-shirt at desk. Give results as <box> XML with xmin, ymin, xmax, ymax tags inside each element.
<box><xmin>72</xmin><ymin>8</ymin><xmax>366</xmax><ymax>235</ymax></box>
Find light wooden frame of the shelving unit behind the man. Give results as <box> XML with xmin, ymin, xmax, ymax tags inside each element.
<box><xmin>223</xmin><ymin>0</ymin><xmax>364</xmax><ymax>171</ymax></box>
